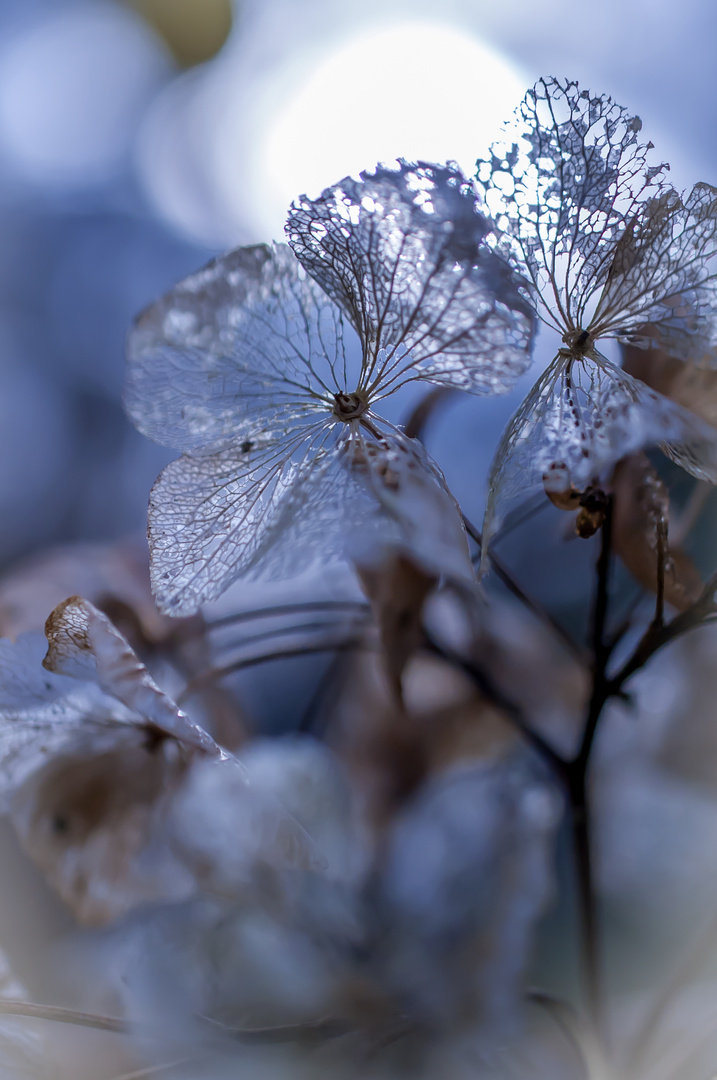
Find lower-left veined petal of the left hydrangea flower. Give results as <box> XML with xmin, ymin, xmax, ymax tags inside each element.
<box><xmin>149</xmin><ymin>422</ymin><xmax>342</xmax><ymax>615</ymax></box>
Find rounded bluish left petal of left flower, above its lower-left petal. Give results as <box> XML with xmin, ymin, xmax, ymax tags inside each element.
<box><xmin>125</xmin><ymin>244</ymin><xmax>361</xmax><ymax>451</ymax></box>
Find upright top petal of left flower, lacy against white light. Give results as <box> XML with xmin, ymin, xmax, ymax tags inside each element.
<box><xmin>286</xmin><ymin>161</ymin><xmax>532</xmax><ymax>395</ymax></box>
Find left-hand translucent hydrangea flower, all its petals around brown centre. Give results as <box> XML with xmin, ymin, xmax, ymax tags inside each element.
<box><xmin>126</xmin><ymin>162</ymin><xmax>532</xmax><ymax>615</ymax></box>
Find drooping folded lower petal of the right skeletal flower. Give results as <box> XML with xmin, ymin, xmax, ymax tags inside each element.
<box><xmin>483</xmin><ymin>353</ymin><xmax>717</xmax><ymax>556</ymax></box>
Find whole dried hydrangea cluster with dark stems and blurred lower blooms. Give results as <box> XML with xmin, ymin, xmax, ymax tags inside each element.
<box><xmin>0</xmin><ymin>79</ymin><xmax>717</xmax><ymax>1080</ymax></box>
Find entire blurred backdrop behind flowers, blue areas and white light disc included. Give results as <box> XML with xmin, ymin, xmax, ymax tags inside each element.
<box><xmin>0</xmin><ymin>0</ymin><xmax>717</xmax><ymax>567</ymax></box>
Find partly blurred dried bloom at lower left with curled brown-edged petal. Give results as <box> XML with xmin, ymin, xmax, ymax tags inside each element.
<box><xmin>0</xmin><ymin>597</ymin><xmax>321</xmax><ymax>923</ymax></box>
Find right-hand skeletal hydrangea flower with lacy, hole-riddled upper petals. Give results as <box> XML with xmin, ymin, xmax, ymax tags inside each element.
<box><xmin>477</xmin><ymin>79</ymin><xmax>717</xmax><ymax>557</ymax></box>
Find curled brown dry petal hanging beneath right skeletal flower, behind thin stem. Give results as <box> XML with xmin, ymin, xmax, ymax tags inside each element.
<box><xmin>612</xmin><ymin>454</ymin><xmax>702</xmax><ymax>611</ymax></box>
